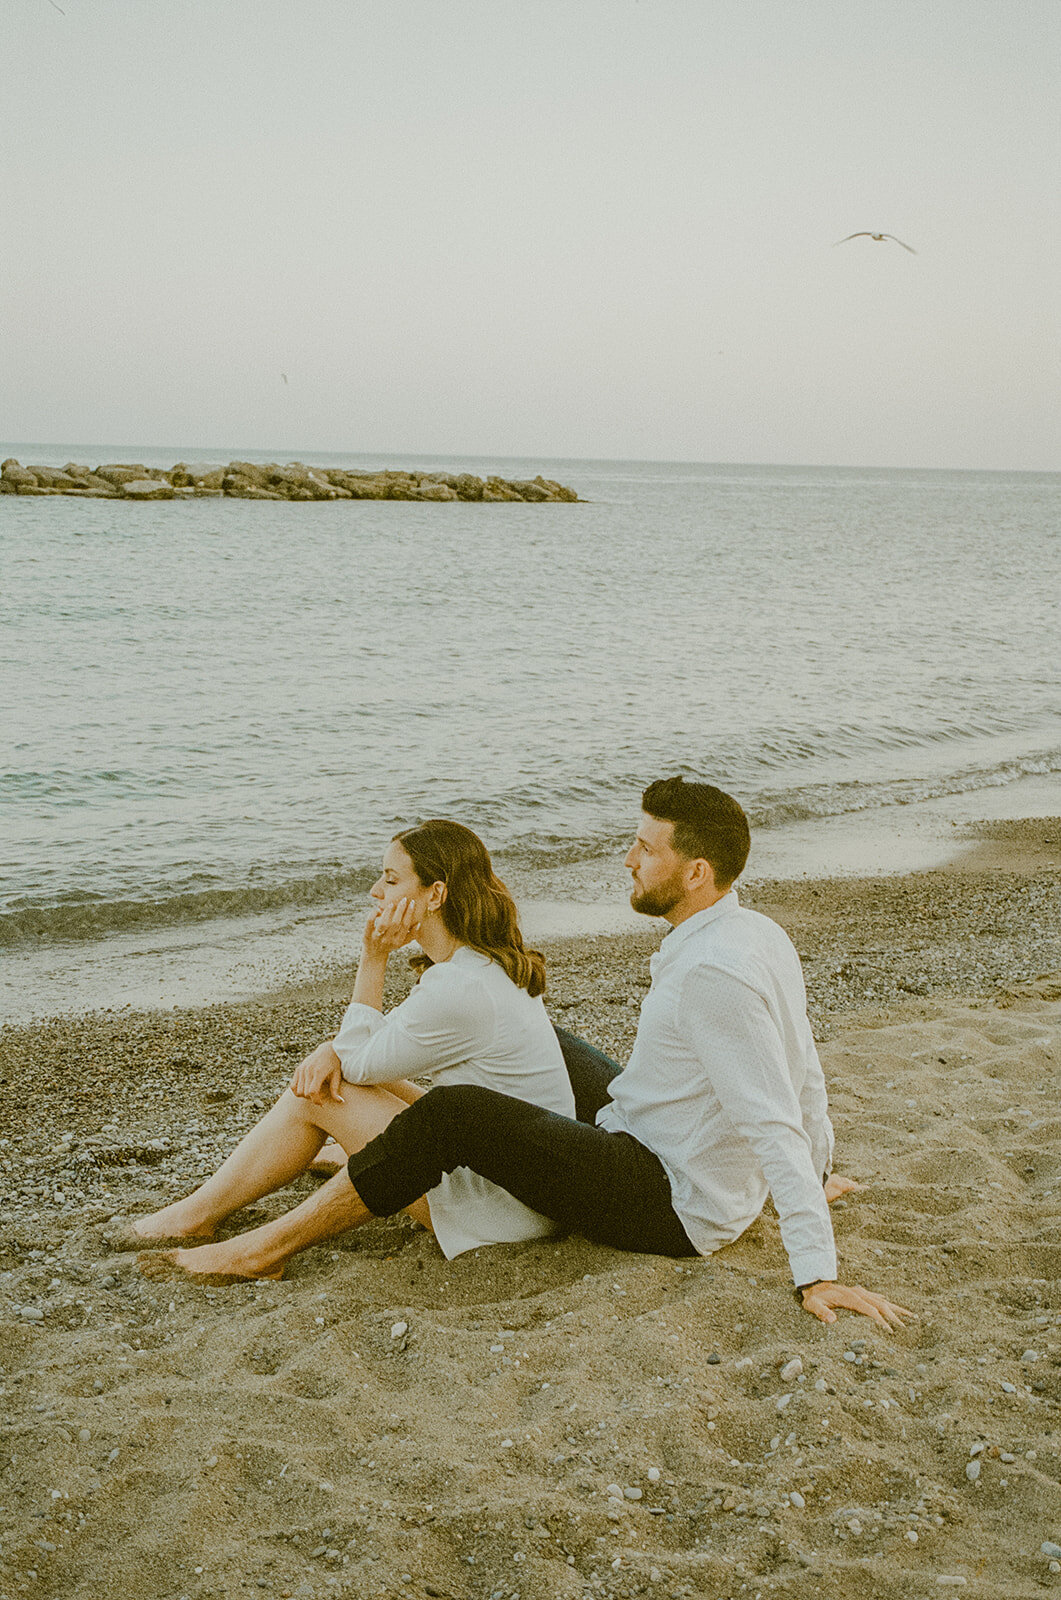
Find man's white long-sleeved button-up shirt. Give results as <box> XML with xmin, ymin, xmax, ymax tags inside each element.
<box><xmin>597</xmin><ymin>890</ymin><xmax>837</xmax><ymax>1283</ymax></box>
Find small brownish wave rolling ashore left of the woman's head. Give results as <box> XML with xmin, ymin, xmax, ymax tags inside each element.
<box><xmin>0</xmin><ymin>867</ymin><xmax>376</xmax><ymax>947</ymax></box>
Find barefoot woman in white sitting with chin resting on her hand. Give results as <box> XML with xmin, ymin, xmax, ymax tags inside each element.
<box><xmin>110</xmin><ymin>821</ymin><xmax>575</xmax><ymax>1258</ymax></box>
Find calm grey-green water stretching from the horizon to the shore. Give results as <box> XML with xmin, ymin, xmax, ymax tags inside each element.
<box><xmin>0</xmin><ymin>445</ymin><xmax>1061</xmax><ymax>946</ymax></box>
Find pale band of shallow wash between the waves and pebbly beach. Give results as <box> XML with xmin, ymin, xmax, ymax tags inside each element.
<box><xmin>0</xmin><ymin>778</ymin><xmax>1058</xmax><ymax>1022</ymax></box>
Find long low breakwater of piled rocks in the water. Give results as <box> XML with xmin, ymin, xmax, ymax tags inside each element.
<box><xmin>0</xmin><ymin>456</ymin><xmax>578</xmax><ymax>502</ymax></box>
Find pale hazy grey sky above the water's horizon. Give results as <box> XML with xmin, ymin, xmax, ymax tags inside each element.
<box><xmin>0</xmin><ymin>0</ymin><xmax>1061</xmax><ymax>470</ymax></box>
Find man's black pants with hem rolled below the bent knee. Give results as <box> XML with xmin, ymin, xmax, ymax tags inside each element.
<box><xmin>347</xmin><ymin>1029</ymin><xmax>696</xmax><ymax>1256</ymax></box>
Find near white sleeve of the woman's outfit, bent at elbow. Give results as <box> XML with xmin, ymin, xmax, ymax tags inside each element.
<box><xmin>333</xmin><ymin>966</ymin><xmax>493</xmax><ymax>1083</ymax></box>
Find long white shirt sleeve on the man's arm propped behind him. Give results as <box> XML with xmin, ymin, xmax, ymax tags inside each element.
<box><xmin>680</xmin><ymin>966</ymin><xmax>837</xmax><ymax>1283</ymax></box>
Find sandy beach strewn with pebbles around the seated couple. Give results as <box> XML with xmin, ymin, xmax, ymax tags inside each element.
<box><xmin>0</xmin><ymin>821</ymin><xmax>1061</xmax><ymax>1600</ymax></box>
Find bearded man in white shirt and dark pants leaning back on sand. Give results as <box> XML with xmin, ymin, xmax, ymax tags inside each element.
<box><xmin>139</xmin><ymin>778</ymin><xmax>912</xmax><ymax>1328</ymax></box>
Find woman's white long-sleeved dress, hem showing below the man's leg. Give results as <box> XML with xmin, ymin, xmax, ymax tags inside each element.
<box><xmin>333</xmin><ymin>944</ymin><xmax>575</xmax><ymax>1259</ymax></box>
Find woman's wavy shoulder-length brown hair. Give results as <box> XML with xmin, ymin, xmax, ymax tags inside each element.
<box><xmin>394</xmin><ymin>818</ymin><xmax>546</xmax><ymax>995</ymax></box>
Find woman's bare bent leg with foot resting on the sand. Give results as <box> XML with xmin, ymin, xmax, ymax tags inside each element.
<box><xmin>133</xmin><ymin>1083</ymin><xmax>429</xmax><ymax>1243</ymax></box>
